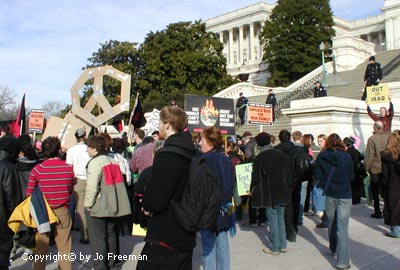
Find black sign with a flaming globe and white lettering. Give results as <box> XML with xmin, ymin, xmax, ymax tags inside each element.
<box><xmin>185</xmin><ymin>95</ymin><xmax>235</xmax><ymax>135</ymax></box>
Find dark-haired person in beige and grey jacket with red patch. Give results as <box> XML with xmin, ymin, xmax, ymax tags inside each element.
<box><xmin>84</xmin><ymin>133</ymin><xmax>131</xmax><ymax>269</ymax></box>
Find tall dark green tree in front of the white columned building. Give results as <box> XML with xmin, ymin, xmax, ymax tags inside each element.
<box><xmin>261</xmin><ymin>0</ymin><xmax>335</xmax><ymax>85</ymax></box>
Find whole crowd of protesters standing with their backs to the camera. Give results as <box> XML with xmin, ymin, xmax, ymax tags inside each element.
<box><xmin>0</xmin><ymin>104</ymin><xmax>400</xmax><ymax>270</ymax></box>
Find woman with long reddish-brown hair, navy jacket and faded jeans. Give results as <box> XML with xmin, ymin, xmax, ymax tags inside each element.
<box><xmin>315</xmin><ymin>133</ymin><xmax>354</xmax><ymax>269</ymax></box>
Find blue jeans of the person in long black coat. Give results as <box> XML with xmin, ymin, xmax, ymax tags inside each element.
<box><xmin>265</xmin><ymin>206</ymin><xmax>287</xmax><ymax>252</ymax></box>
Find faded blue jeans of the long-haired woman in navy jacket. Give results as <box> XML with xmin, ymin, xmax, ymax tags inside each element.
<box><xmin>325</xmin><ymin>196</ymin><xmax>352</xmax><ymax>265</ymax></box>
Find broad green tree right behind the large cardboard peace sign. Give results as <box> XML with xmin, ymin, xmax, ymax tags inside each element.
<box><xmin>135</xmin><ymin>21</ymin><xmax>236</xmax><ymax>110</ymax></box>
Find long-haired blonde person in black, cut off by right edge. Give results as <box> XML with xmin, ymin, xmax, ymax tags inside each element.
<box><xmin>381</xmin><ymin>133</ymin><xmax>400</xmax><ymax>238</ymax></box>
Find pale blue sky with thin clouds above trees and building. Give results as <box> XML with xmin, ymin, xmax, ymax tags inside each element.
<box><xmin>0</xmin><ymin>0</ymin><xmax>384</xmax><ymax>108</ymax></box>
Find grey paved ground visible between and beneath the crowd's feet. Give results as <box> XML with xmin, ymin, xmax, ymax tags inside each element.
<box><xmin>11</xmin><ymin>200</ymin><xmax>400</xmax><ymax>270</ymax></box>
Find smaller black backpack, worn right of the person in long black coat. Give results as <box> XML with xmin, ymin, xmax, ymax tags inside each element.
<box><xmin>292</xmin><ymin>146</ymin><xmax>313</xmax><ymax>182</ymax></box>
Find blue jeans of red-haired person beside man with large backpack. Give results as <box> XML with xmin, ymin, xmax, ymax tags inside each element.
<box><xmin>200</xmin><ymin>230</ymin><xmax>230</xmax><ymax>270</ymax></box>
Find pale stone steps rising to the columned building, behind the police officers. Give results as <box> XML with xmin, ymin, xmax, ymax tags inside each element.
<box><xmin>236</xmin><ymin>50</ymin><xmax>400</xmax><ymax>137</ymax></box>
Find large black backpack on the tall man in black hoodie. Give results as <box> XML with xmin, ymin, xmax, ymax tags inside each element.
<box><xmin>157</xmin><ymin>146</ymin><xmax>222</xmax><ymax>232</ymax></box>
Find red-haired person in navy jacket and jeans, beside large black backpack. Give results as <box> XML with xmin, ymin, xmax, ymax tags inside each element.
<box><xmin>200</xmin><ymin>127</ymin><xmax>236</xmax><ymax>270</ymax></box>
